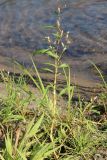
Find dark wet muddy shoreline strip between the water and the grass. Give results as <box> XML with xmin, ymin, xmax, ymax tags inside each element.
<box><xmin>0</xmin><ymin>66</ymin><xmax>106</xmax><ymax>102</ymax></box>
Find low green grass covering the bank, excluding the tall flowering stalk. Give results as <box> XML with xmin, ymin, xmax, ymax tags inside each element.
<box><xmin>0</xmin><ymin>69</ymin><xmax>107</xmax><ymax>160</ymax></box>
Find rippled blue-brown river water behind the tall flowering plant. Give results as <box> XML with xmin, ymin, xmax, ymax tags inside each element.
<box><xmin>0</xmin><ymin>0</ymin><xmax>107</xmax><ymax>86</ymax></box>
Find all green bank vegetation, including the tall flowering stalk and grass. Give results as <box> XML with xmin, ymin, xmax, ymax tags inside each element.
<box><xmin>0</xmin><ymin>2</ymin><xmax>107</xmax><ymax>160</ymax></box>
